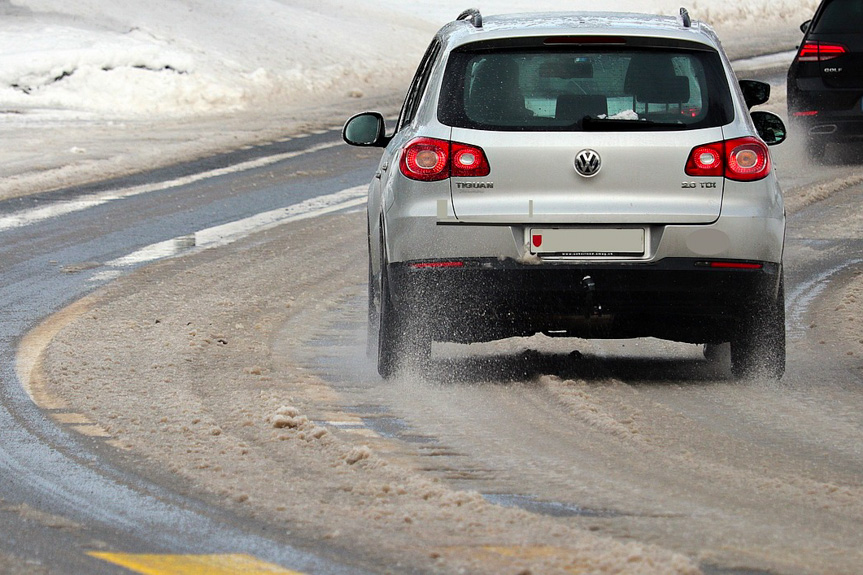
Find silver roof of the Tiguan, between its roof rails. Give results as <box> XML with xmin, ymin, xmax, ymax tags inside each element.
<box><xmin>440</xmin><ymin>12</ymin><xmax>719</xmax><ymax>49</ymax></box>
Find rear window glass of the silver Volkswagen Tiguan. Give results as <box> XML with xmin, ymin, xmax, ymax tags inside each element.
<box><xmin>438</xmin><ymin>44</ymin><xmax>734</xmax><ymax>131</ymax></box>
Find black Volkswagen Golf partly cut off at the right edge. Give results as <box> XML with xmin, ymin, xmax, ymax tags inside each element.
<box><xmin>788</xmin><ymin>0</ymin><xmax>863</xmax><ymax>159</ymax></box>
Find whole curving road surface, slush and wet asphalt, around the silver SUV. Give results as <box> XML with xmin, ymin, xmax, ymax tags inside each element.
<box><xmin>5</xmin><ymin>60</ymin><xmax>863</xmax><ymax>573</ymax></box>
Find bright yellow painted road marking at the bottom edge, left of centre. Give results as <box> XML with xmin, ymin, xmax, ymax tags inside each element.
<box><xmin>88</xmin><ymin>552</ymin><xmax>302</xmax><ymax>575</ymax></box>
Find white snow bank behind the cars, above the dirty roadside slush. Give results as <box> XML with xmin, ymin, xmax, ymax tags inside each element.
<box><xmin>0</xmin><ymin>0</ymin><xmax>816</xmax><ymax>118</ymax></box>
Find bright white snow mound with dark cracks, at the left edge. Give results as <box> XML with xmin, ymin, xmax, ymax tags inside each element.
<box><xmin>0</xmin><ymin>25</ymin><xmax>248</xmax><ymax>115</ymax></box>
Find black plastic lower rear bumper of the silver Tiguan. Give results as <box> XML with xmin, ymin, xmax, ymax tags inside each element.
<box><xmin>388</xmin><ymin>258</ymin><xmax>781</xmax><ymax>343</ymax></box>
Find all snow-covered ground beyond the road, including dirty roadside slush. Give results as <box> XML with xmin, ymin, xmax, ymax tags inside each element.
<box><xmin>0</xmin><ymin>0</ymin><xmax>817</xmax><ymax>198</ymax></box>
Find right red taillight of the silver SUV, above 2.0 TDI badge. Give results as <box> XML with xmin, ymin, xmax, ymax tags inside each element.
<box><xmin>686</xmin><ymin>137</ymin><xmax>771</xmax><ymax>182</ymax></box>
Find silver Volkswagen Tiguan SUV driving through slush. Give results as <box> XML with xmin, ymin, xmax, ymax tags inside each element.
<box><xmin>343</xmin><ymin>9</ymin><xmax>785</xmax><ymax>379</ymax></box>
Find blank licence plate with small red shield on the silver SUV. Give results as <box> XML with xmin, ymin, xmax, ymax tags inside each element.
<box><xmin>530</xmin><ymin>228</ymin><xmax>645</xmax><ymax>257</ymax></box>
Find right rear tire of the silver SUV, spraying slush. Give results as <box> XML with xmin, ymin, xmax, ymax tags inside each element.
<box><xmin>731</xmin><ymin>280</ymin><xmax>785</xmax><ymax>381</ymax></box>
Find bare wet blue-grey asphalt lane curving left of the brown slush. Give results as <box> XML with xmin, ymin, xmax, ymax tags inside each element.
<box><xmin>0</xmin><ymin>131</ymin><xmax>382</xmax><ymax>573</ymax></box>
